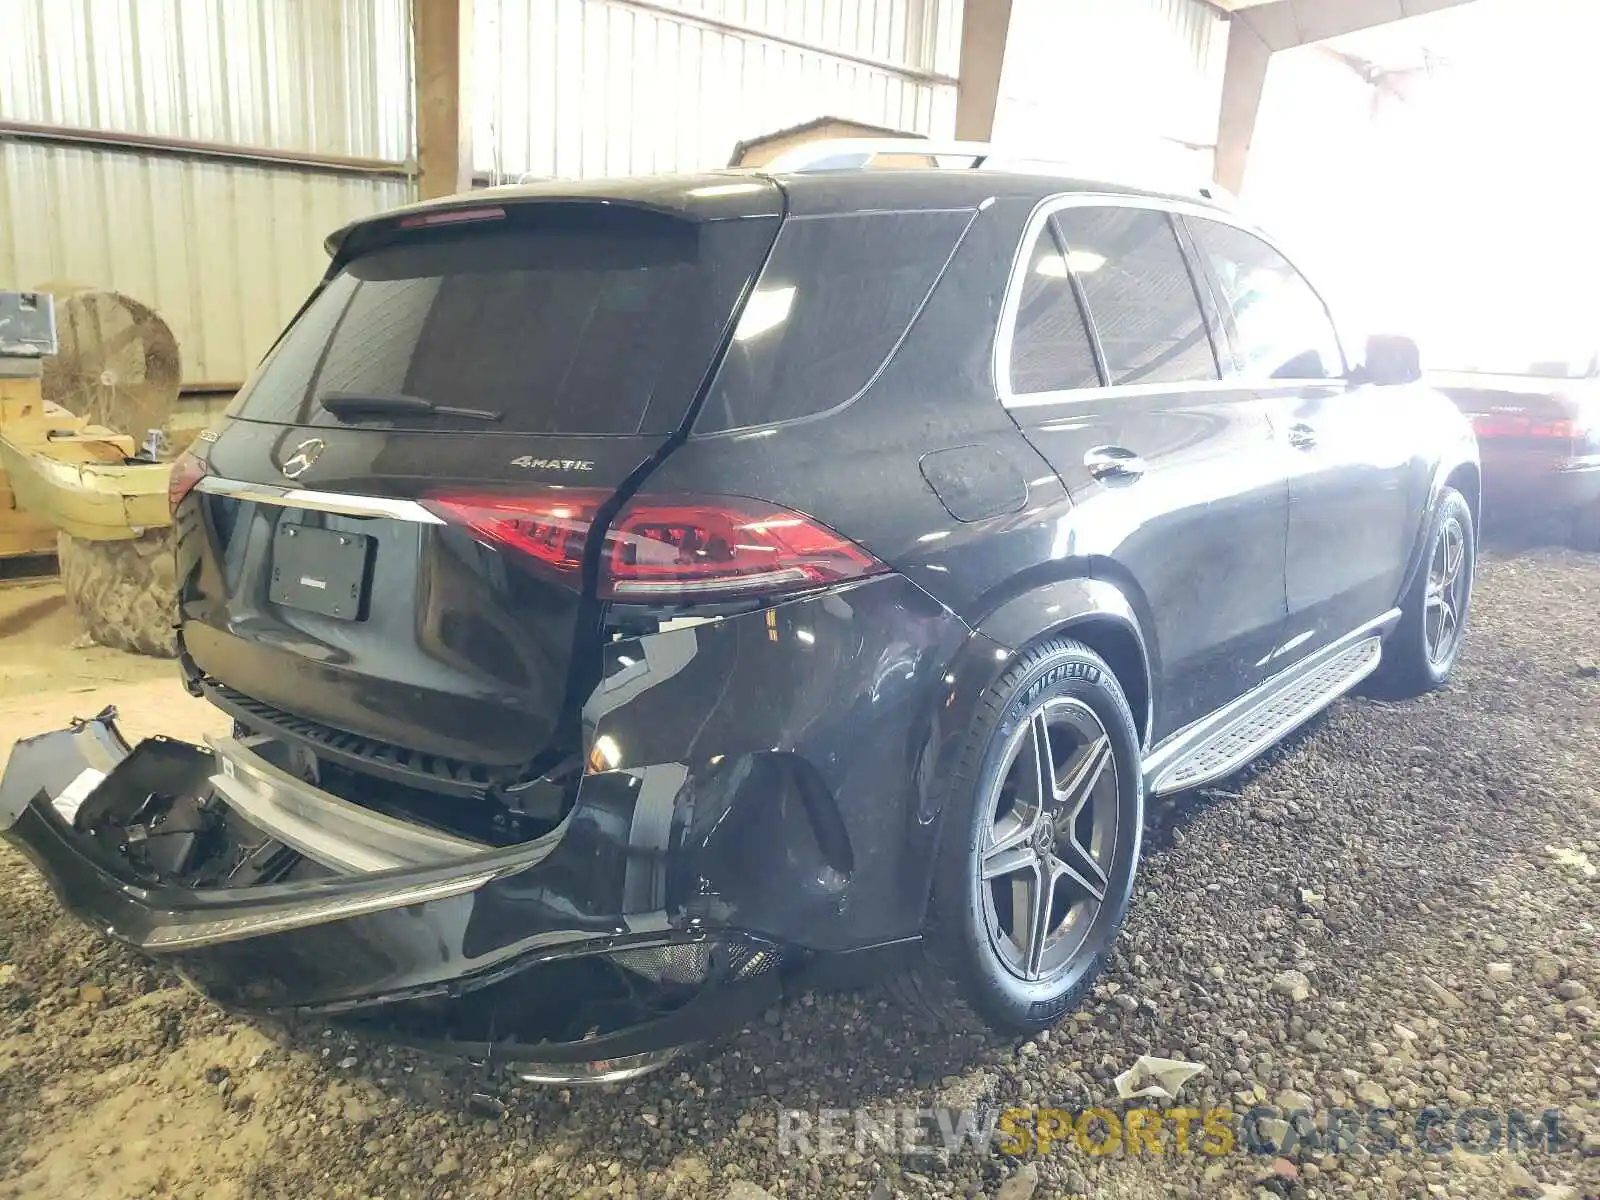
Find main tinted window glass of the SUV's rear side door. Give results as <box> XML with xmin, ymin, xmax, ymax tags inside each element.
<box><xmin>1051</xmin><ymin>208</ymin><xmax>1219</xmax><ymax>384</ymax></box>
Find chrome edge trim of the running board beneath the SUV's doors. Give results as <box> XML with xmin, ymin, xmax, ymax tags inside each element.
<box><xmin>1144</xmin><ymin>608</ymin><xmax>1400</xmax><ymax>795</ymax></box>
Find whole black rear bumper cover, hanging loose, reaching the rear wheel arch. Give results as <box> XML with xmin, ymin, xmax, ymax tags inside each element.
<box><xmin>0</xmin><ymin>576</ymin><xmax>979</xmax><ymax>1061</ymax></box>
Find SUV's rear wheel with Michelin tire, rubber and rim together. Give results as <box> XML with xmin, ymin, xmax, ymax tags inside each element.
<box><xmin>901</xmin><ymin>638</ymin><xmax>1144</xmax><ymax>1034</ymax></box>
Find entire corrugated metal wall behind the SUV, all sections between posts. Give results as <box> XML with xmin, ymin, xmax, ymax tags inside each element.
<box><xmin>0</xmin><ymin>0</ymin><xmax>1224</xmax><ymax>382</ymax></box>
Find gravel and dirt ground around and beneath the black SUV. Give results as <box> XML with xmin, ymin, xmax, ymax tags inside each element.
<box><xmin>0</xmin><ymin>546</ymin><xmax>1600</xmax><ymax>1200</ymax></box>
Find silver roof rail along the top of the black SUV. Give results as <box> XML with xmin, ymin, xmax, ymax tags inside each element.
<box><xmin>758</xmin><ymin>138</ymin><xmax>1238</xmax><ymax>208</ymax></box>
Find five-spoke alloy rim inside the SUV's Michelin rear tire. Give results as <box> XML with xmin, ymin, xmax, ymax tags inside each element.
<box><xmin>978</xmin><ymin>698</ymin><xmax>1120</xmax><ymax>981</ymax></box>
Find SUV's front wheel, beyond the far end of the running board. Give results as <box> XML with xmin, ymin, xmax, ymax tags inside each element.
<box><xmin>1379</xmin><ymin>488</ymin><xmax>1478</xmax><ymax>696</ymax></box>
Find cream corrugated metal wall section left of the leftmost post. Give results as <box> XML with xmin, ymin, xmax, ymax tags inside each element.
<box><xmin>0</xmin><ymin>0</ymin><xmax>411</xmax><ymax>382</ymax></box>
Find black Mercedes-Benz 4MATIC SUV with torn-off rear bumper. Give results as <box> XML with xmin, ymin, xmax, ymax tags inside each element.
<box><xmin>0</xmin><ymin>145</ymin><xmax>1478</xmax><ymax>1080</ymax></box>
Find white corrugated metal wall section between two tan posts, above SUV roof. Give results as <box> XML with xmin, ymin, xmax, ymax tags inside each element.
<box><xmin>475</xmin><ymin>0</ymin><xmax>962</xmax><ymax>178</ymax></box>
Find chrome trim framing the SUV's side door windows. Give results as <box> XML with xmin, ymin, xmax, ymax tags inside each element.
<box><xmin>994</xmin><ymin>192</ymin><xmax>1344</xmax><ymax>408</ymax></box>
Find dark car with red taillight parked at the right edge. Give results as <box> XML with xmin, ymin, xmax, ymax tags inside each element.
<box><xmin>1429</xmin><ymin>347</ymin><xmax>1600</xmax><ymax>549</ymax></box>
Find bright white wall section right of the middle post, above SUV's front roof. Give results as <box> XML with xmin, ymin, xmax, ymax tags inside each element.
<box><xmin>994</xmin><ymin>0</ymin><xmax>1227</xmax><ymax>179</ymax></box>
